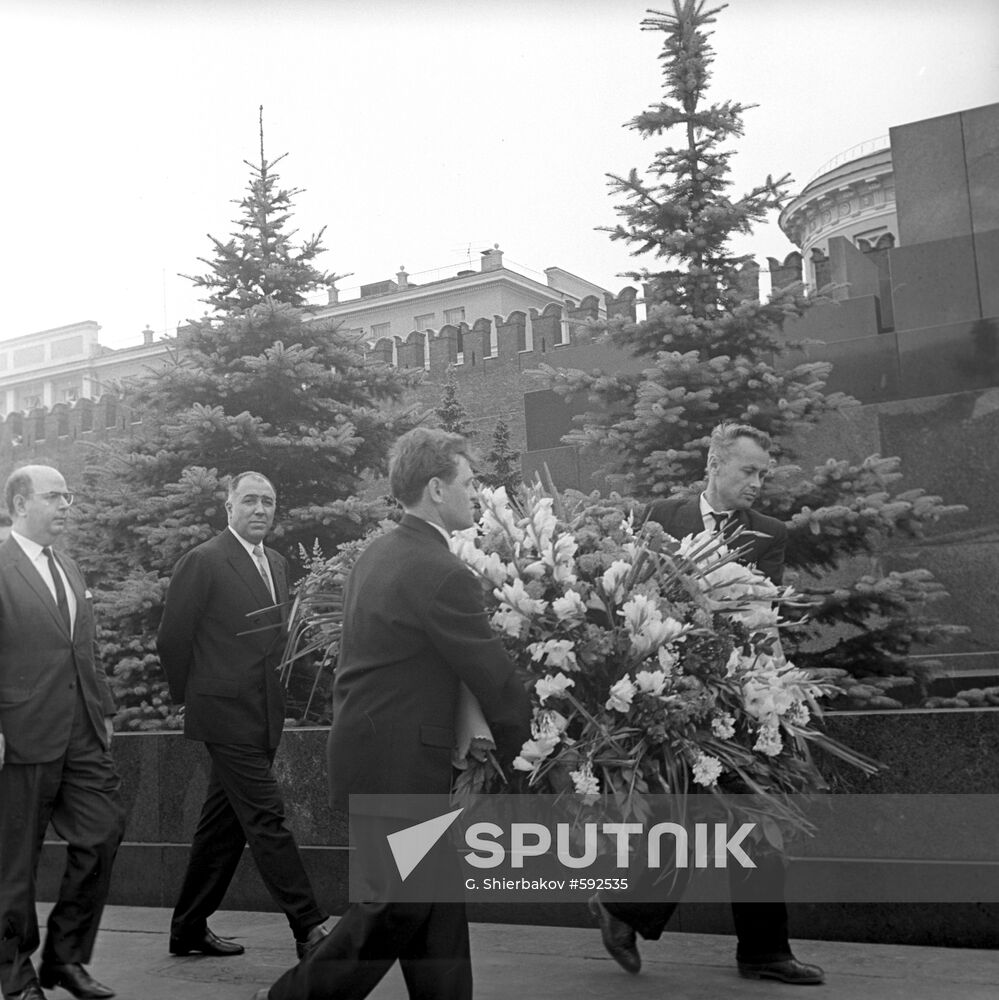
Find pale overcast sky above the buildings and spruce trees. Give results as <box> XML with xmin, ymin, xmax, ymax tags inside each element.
<box><xmin>0</xmin><ymin>0</ymin><xmax>999</xmax><ymax>347</ymax></box>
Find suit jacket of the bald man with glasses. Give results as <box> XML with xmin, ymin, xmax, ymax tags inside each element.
<box><xmin>0</xmin><ymin>538</ymin><xmax>115</xmax><ymax>764</ymax></box>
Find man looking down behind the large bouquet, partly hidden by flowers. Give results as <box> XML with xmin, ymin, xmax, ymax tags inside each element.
<box><xmin>590</xmin><ymin>423</ymin><xmax>824</xmax><ymax>985</ymax></box>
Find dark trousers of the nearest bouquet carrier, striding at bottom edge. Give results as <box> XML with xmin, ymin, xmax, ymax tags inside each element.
<box><xmin>269</xmin><ymin>816</ymin><xmax>472</xmax><ymax>1000</ymax></box>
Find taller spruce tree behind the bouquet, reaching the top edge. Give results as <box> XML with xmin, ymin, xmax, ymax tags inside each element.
<box><xmin>553</xmin><ymin>0</ymin><xmax>960</xmax><ymax>705</ymax></box>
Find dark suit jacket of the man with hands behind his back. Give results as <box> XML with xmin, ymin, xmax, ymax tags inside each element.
<box><xmin>156</xmin><ymin>528</ymin><xmax>288</xmax><ymax>748</ymax></box>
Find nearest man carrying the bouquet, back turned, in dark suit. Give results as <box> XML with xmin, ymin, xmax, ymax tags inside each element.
<box><xmin>256</xmin><ymin>428</ymin><xmax>531</xmax><ymax>1000</ymax></box>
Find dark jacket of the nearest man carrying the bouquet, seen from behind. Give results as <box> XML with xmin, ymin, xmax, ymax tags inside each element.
<box><xmin>329</xmin><ymin>514</ymin><xmax>531</xmax><ymax>809</ymax></box>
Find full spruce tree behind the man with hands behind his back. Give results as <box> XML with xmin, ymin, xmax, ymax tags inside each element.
<box><xmin>80</xmin><ymin>119</ymin><xmax>415</xmax><ymax>728</ymax></box>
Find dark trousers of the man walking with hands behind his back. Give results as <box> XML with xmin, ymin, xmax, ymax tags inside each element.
<box><xmin>170</xmin><ymin>743</ymin><xmax>326</xmax><ymax>940</ymax></box>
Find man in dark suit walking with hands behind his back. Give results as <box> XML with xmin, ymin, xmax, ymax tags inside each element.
<box><xmin>156</xmin><ymin>472</ymin><xmax>331</xmax><ymax>956</ymax></box>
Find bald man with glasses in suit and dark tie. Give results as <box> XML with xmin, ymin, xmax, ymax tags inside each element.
<box><xmin>0</xmin><ymin>465</ymin><xmax>124</xmax><ymax>1000</ymax></box>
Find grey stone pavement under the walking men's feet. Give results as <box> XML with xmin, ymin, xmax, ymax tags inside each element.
<box><xmin>39</xmin><ymin>906</ymin><xmax>999</xmax><ymax>1000</ymax></box>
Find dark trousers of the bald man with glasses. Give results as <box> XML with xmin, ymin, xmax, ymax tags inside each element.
<box><xmin>0</xmin><ymin>697</ymin><xmax>125</xmax><ymax>996</ymax></box>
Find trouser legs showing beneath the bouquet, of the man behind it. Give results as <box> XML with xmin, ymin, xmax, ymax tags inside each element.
<box><xmin>601</xmin><ymin>852</ymin><xmax>791</xmax><ymax>962</ymax></box>
